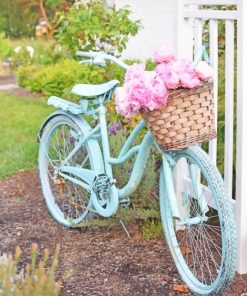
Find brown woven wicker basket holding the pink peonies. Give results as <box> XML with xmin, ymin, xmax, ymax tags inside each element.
<box><xmin>141</xmin><ymin>83</ymin><xmax>216</xmax><ymax>151</ymax></box>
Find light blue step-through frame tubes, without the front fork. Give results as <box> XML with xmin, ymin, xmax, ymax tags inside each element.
<box><xmin>61</xmin><ymin>103</ymin><xmax>154</xmax><ymax>199</ymax></box>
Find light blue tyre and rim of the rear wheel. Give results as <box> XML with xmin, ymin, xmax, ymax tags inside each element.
<box><xmin>39</xmin><ymin>114</ymin><xmax>102</xmax><ymax>227</ymax></box>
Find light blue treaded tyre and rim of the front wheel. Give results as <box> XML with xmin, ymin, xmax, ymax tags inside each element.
<box><xmin>160</xmin><ymin>146</ymin><xmax>237</xmax><ymax>295</ymax></box>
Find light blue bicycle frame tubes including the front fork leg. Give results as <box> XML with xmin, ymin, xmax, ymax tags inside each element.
<box><xmin>59</xmin><ymin>101</ymin><xmax>180</xmax><ymax>219</ymax></box>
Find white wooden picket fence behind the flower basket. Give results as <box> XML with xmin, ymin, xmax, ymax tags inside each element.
<box><xmin>174</xmin><ymin>0</ymin><xmax>247</xmax><ymax>274</ymax></box>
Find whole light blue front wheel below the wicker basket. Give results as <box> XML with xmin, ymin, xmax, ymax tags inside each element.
<box><xmin>160</xmin><ymin>146</ymin><xmax>237</xmax><ymax>295</ymax></box>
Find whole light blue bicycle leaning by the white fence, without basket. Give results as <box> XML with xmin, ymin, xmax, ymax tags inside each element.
<box><xmin>39</xmin><ymin>52</ymin><xmax>237</xmax><ymax>295</ymax></box>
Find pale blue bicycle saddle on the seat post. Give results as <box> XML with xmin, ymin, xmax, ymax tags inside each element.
<box><xmin>71</xmin><ymin>80</ymin><xmax>119</xmax><ymax>97</ymax></box>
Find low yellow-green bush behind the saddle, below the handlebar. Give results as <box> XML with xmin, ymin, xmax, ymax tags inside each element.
<box><xmin>18</xmin><ymin>59</ymin><xmax>124</xmax><ymax>96</ymax></box>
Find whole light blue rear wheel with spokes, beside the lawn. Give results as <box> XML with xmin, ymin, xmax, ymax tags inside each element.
<box><xmin>39</xmin><ymin>115</ymin><xmax>101</xmax><ymax>227</ymax></box>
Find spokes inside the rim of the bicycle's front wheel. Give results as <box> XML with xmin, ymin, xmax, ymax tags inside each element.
<box><xmin>176</xmin><ymin>157</ymin><xmax>222</xmax><ymax>285</ymax></box>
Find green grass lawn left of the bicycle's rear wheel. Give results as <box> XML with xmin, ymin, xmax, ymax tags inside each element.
<box><xmin>0</xmin><ymin>92</ymin><xmax>53</xmax><ymax>179</ymax></box>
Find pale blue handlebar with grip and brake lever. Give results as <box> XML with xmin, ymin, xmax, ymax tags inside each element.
<box><xmin>76</xmin><ymin>51</ymin><xmax>129</xmax><ymax>70</ymax></box>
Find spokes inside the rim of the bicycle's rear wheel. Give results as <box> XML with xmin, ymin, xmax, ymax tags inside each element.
<box><xmin>43</xmin><ymin>124</ymin><xmax>93</xmax><ymax>220</ymax></box>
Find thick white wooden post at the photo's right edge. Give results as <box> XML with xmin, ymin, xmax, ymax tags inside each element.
<box><xmin>236</xmin><ymin>0</ymin><xmax>247</xmax><ymax>274</ymax></box>
